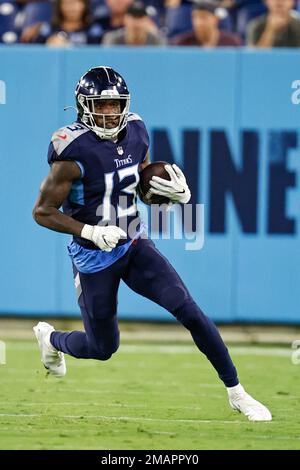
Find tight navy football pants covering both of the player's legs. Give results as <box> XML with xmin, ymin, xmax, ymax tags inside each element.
<box><xmin>51</xmin><ymin>239</ymin><xmax>238</xmax><ymax>387</ymax></box>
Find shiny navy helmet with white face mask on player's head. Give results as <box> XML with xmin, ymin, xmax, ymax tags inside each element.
<box><xmin>75</xmin><ymin>67</ymin><xmax>130</xmax><ymax>140</ymax></box>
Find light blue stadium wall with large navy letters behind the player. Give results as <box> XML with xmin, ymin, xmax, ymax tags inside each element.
<box><xmin>0</xmin><ymin>47</ymin><xmax>300</xmax><ymax>323</ymax></box>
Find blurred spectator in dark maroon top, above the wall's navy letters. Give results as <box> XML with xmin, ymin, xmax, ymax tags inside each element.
<box><xmin>172</xmin><ymin>1</ymin><xmax>241</xmax><ymax>47</ymax></box>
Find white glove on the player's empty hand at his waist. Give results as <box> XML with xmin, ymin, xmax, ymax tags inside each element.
<box><xmin>81</xmin><ymin>224</ymin><xmax>127</xmax><ymax>252</ymax></box>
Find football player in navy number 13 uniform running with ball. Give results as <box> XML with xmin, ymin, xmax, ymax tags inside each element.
<box><xmin>33</xmin><ymin>67</ymin><xmax>272</xmax><ymax>421</ymax></box>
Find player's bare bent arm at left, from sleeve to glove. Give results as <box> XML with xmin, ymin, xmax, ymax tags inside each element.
<box><xmin>33</xmin><ymin>161</ymin><xmax>84</xmax><ymax>237</ymax></box>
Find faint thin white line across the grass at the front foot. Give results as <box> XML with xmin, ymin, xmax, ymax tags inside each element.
<box><xmin>0</xmin><ymin>413</ymin><xmax>260</xmax><ymax>425</ymax></box>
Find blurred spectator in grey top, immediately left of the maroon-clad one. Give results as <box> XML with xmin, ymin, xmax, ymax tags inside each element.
<box><xmin>102</xmin><ymin>1</ymin><xmax>166</xmax><ymax>46</ymax></box>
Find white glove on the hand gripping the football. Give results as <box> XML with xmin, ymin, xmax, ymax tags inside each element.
<box><xmin>149</xmin><ymin>164</ymin><xmax>191</xmax><ymax>204</ymax></box>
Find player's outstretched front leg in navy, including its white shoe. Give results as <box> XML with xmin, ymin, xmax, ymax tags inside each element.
<box><xmin>123</xmin><ymin>240</ymin><xmax>271</xmax><ymax>420</ymax></box>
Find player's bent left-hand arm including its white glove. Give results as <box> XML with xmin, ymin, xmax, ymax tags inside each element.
<box><xmin>33</xmin><ymin>161</ymin><xmax>127</xmax><ymax>252</ymax></box>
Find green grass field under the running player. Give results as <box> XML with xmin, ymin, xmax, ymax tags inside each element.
<box><xmin>0</xmin><ymin>340</ymin><xmax>300</xmax><ymax>450</ymax></box>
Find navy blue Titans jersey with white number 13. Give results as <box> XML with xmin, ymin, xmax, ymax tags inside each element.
<box><xmin>48</xmin><ymin>113</ymin><xmax>149</xmax><ymax>249</ymax></box>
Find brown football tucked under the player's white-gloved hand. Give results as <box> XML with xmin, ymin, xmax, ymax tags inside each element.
<box><xmin>138</xmin><ymin>161</ymin><xmax>170</xmax><ymax>205</ymax></box>
